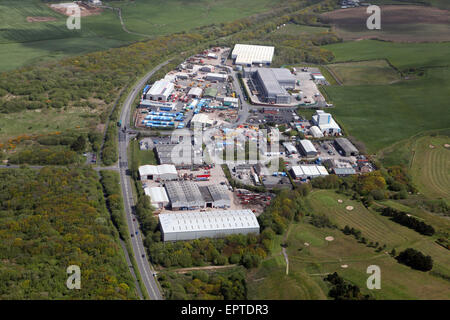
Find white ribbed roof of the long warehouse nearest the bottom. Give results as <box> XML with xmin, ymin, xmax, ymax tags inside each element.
<box><xmin>159</xmin><ymin>209</ymin><xmax>259</xmax><ymax>235</ymax></box>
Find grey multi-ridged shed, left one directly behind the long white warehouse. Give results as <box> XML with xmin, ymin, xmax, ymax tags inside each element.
<box><xmin>165</xmin><ymin>181</ymin><xmax>205</xmax><ymax>210</ymax></box>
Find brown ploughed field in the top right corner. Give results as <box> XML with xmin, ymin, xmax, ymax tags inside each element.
<box><xmin>321</xmin><ymin>5</ymin><xmax>450</xmax><ymax>42</ymax></box>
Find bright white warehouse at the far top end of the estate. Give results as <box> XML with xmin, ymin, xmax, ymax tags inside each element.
<box><xmin>231</xmin><ymin>44</ymin><xmax>275</xmax><ymax>67</ymax></box>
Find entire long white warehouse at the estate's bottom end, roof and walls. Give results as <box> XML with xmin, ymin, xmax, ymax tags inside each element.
<box><xmin>159</xmin><ymin>210</ymin><xmax>259</xmax><ymax>241</ymax></box>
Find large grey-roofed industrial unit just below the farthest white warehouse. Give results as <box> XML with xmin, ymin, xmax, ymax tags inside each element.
<box><xmin>245</xmin><ymin>68</ymin><xmax>295</xmax><ymax>104</ymax></box>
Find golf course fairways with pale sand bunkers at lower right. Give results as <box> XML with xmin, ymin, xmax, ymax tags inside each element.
<box><xmin>248</xmin><ymin>190</ymin><xmax>450</xmax><ymax>299</ymax></box>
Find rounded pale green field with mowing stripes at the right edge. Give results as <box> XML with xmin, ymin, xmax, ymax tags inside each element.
<box><xmin>411</xmin><ymin>136</ymin><xmax>450</xmax><ymax>202</ymax></box>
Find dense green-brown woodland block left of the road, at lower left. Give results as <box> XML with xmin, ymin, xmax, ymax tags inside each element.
<box><xmin>0</xmin><ymin>167</ymin><xmax>136</xmax><ymax>300</ymax></box>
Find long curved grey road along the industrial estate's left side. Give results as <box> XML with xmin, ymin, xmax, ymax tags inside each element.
<box><xmin>118</xmin><ymin>60</ymin><xmax>170</xmax><ymax>300</ymax></box>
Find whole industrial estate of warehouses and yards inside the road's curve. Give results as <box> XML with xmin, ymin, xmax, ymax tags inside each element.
<box><xmin>134</xmin><ymin>44</ymin><xmax>374</xmax><ymax>241</ymax></box>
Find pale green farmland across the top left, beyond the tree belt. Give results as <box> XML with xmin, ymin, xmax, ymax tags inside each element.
<box><xmin>0</xmin><ymin>0</ymin><xmax>286</xmax><ymax>72</ymax></box>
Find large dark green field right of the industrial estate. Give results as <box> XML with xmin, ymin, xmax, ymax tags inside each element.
<box><xmin>324</xmin><ymin>68</ymin><xmax>450</xmax><ymax>153</ymax></box>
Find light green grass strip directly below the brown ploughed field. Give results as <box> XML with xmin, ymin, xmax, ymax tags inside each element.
<box><xmin>322</xmin><ymin>40</ymin><xmax>450</xmax><ymax>70</ymax></box>
